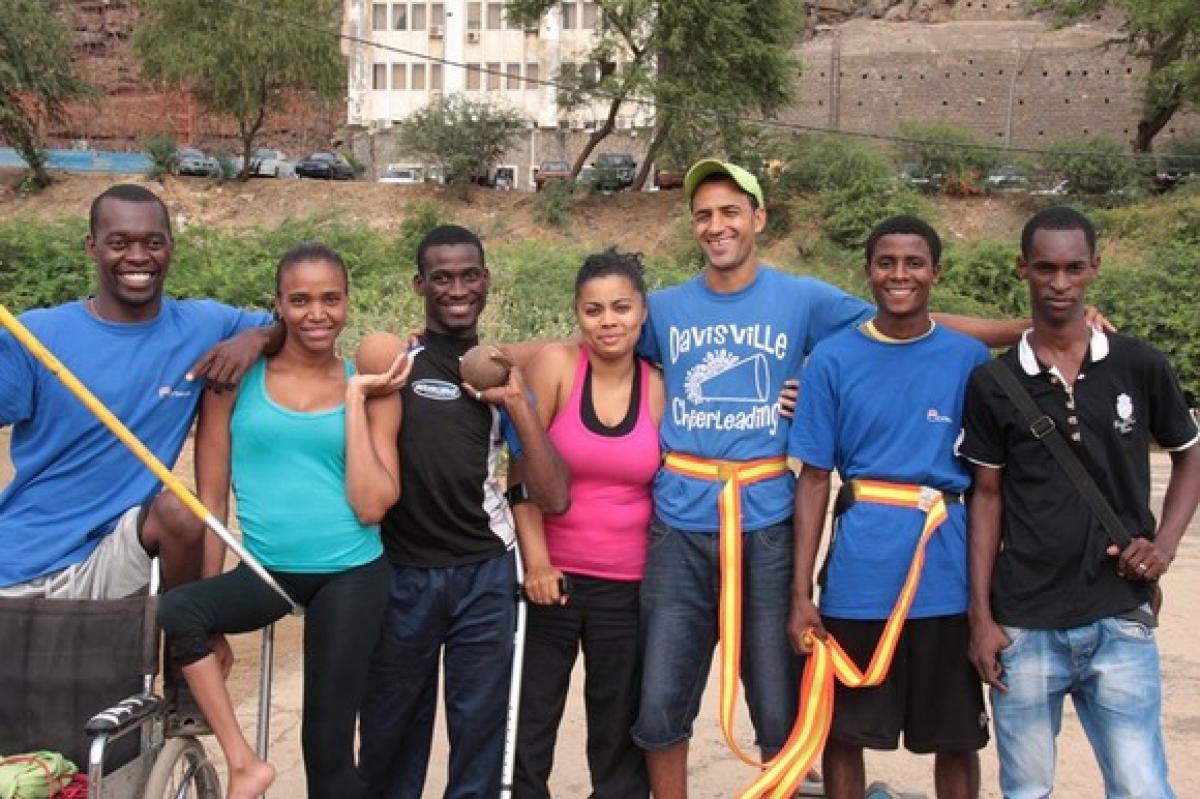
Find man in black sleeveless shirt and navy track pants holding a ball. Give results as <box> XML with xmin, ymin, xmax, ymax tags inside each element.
<box><xmin>360</xmin><ymin>226</ymin><xmax>569</xmax><ymax>799</ymax></box>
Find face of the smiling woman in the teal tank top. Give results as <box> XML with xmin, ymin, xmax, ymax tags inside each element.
<box><xmin>275</xmin><ymin>260</ymin><xmax>347</xmax><ymax>352</ymax></box>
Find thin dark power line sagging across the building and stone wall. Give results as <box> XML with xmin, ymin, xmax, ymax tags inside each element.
<box><xmin>204</xmin><ymin>0</ymin><xmax>1200</xmax><ymax>163</ymax></box>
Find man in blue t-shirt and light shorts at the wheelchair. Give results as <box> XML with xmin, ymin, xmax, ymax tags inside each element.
<box><xmin>0</xmin><ymin>185</ymin><xmax>270</xmax><ymax>599</ymax></box>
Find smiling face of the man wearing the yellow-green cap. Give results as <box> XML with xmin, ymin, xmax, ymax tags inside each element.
<box><xmin>691</xmin><ymin>179</ymin><xmax>767</xmax><ymax>271</ymax></box>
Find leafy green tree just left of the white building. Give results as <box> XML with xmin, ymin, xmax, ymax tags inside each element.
<box><xmin>133</xmin><ymin>0</ymin><xmax>346</xmax><ymax>180</ymax></box>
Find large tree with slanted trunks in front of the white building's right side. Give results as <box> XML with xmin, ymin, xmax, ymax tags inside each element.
<box><xmin>509</xmin><ymin>0</ymin><xmax>803</xmax><ymax>188</ymax></box>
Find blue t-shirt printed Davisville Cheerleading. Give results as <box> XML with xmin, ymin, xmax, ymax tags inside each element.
<box><xmin>638</xmin><ymin>266</ymin><xmax>875</xmax><ymax>533</ymax></box>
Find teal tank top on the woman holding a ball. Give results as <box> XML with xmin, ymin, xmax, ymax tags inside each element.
<box><xmin>229</xmin><ymin>359</ymin><xmax>383</xmax><ymax>573</ymax></box>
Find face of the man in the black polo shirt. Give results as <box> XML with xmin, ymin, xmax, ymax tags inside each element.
<box><xmin>1016</xmin><ymin>228</ymin><xmax>1100</xmax><ymax>326</ymax></box>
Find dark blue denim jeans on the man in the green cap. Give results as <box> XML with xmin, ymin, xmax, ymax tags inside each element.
<box><xmin>632</xmin><ymin>518</ymin><xmax>802</xmax><ymax>757</ymax></box>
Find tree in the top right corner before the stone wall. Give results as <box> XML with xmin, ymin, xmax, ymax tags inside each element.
<box><xmin>1027</xmin><ymin>0</ymin><xmax>1200</xmax><ymax>152</ymax></box>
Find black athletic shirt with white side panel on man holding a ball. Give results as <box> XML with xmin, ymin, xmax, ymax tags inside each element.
<box><xmin>380</xmin><ymin>331</ymin><xmax>515</xmax><ymax>567</ymax></box>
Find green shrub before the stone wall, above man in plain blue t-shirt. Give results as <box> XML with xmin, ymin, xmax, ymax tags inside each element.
<box><xmin>896</xmin><ymin>122</ymin><xmax>1000</xmax><ymax>194</ymax></box>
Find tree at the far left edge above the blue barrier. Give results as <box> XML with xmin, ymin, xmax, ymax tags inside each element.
<box><xmin>0</xmin><ymin>0</ymin><xmax>92</xmax><ymax>188</ymax></box>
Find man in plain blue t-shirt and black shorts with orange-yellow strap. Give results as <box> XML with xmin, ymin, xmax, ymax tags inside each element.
<box><xmin>788</xmin><ymin>216</ymin><xmax>988</xmax><ymax>799</ymax></box>
